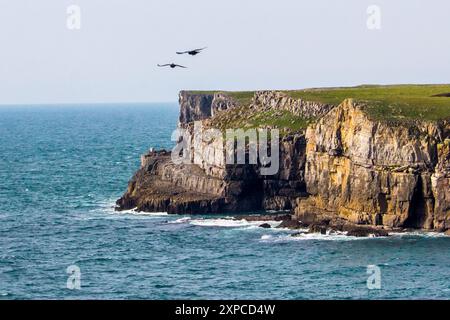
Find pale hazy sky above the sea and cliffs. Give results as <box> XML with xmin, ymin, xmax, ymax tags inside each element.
<box><xmin>0</xmin><ymin>0</ymin><xmax>450</xmax><ymax>104</ymax></box>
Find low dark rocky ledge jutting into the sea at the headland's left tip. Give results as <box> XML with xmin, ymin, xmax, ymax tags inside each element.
<box><xmin>117</xmin><ymin>151</ymin><xmax>261</xmax><ymax>214</ymax></box>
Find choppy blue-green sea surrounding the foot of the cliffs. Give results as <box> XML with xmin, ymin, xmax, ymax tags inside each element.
<box><xmin>0</xmin><ymin>104</ymin><xmax>450</xmax><ymax>299</ymax></box>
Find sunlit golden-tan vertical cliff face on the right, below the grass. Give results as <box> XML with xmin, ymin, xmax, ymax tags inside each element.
<box><xmin>295</xmin><ymin>100</ymin><xmax>450</xmax><ymax>229</ymax></box>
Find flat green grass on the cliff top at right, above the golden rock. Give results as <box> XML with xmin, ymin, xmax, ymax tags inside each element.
<box><xmin>285</xmin><ymin>85</ymin><xmax>450</xmax><ymax>121</ymax></box>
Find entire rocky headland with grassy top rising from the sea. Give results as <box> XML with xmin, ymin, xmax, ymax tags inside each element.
<box><xmin>117</xmin><ymin>86</ymin><xmax>450</xmax><ymax>231</ymax></box>
